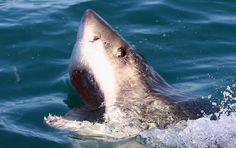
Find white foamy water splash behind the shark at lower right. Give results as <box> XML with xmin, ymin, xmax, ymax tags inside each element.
<box><xmin>136</xmin><ymin>84</ymin><xmax>236</xmax><ymax>148</ymax></box>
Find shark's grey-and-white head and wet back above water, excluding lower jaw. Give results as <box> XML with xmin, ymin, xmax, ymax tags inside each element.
<box><xmin>67</xmin><ymin>9</ymin><xmax>218</xmax><ymax>130</ymax></box>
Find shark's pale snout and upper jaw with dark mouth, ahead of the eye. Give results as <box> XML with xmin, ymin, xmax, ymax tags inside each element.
<box><xmin>69</xmin><ymin>9</ymin><xmax>123</xmax><ymax>106</ymax></box>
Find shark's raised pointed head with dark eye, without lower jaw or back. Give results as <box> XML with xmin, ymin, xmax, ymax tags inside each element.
<box><xmin>69</xmin><ymin>9</ymin><xmax>167</xmax><ymax>117</ymax></box>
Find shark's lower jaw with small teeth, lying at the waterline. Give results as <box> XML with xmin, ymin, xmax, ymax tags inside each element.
<box><xmin>44</xmin><ymin>115</ymin><xmax>142</xmax><ymax>141</ymax></box>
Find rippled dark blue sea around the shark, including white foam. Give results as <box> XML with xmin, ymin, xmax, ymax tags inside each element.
<box><xmin>0</xmin><ymin>0</ymin><xmax>236</xmax><ymax>147</ymax></box>
